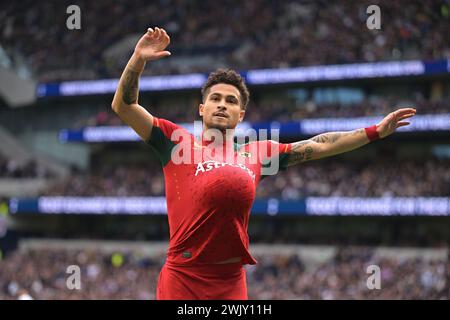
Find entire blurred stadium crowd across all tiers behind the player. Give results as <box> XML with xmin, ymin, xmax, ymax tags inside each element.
<box><xmin>0</xmin><ymin>0</ymin><xmax>450</xmax><ymax>300</ymax></box>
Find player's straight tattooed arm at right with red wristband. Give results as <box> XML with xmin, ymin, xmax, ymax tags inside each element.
<box><xmin>288</xmin><ymin>108</ymin><xmax>416</xmax><ymax>166</ymax></box>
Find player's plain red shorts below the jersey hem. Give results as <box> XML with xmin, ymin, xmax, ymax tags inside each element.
<box><xmin>156</xmin><ymin>262</ymin><xmax>248</xmax><ymax>300</ymax></box>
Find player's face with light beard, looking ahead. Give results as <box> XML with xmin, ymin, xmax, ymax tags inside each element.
<box><xmin>199</xmin><ymin>83</ymin><xmax>245</xmax><ymax>130</ymax></box>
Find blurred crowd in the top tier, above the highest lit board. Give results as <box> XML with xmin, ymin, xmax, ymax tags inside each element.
<box><xmin>0</xmin><ymin>0</ymin><xmax>450</xmax><ymax>82</ymax></box>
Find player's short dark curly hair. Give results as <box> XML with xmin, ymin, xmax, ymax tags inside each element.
<box><xmin>202</xmin><ymin>69</ymin><xmax>250</xmax><ymax>110</ymax></box>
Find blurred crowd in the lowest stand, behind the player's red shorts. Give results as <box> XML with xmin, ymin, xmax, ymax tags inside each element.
<box><xmin>0</xmin><ymin>247</ymin><xmax>450</xmax><ymax>300</ymax></box>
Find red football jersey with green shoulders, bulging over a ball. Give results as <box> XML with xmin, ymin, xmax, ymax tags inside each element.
<box><xmin>146</xmin><ymin>117</ymin><xmax>290</xmax><ymax>265</ymax></box>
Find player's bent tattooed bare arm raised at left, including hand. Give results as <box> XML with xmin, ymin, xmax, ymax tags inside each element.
<box><xmin>111</xmin><ymin>28</ymin><xmax>170</xmax><ymax>140</ymax></box>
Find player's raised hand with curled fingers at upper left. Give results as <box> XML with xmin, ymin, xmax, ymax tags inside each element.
<box><xmin>134</xmin><ymin>27</ymin><xmax>170</xmax><ymax>61</ymax></box>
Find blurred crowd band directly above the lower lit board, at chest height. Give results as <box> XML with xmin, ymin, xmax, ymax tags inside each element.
<box><xmin>46</xmin><ymin>155</ymin><xmax>450</xmax><ymax>200</ymax></box>
